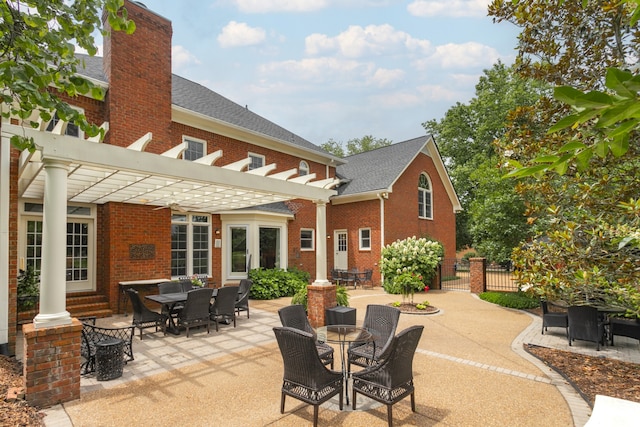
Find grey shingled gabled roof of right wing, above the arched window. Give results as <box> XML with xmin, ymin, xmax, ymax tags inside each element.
<box><xmin>332</xmin><ymin>135</ymin><xmax>462</xmax><ymax>211</ymax></box>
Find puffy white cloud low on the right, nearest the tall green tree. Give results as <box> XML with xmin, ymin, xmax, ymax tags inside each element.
<box><xmin>426</xmin><ymin>42</ymin><xmax>500</xmax><ymax>68</ymax></box>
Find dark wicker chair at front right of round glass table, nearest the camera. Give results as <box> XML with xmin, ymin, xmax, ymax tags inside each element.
<box><xmin>351</xmin><ymin>325</ymin><xmax>424</xmax><ymax>426</ymax></box>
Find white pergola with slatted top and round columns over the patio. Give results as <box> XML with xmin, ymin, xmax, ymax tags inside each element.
<box><xmin>0</xmin><ymin>121</ymin><xmax>339</xmax><ymax>327</ymax></box>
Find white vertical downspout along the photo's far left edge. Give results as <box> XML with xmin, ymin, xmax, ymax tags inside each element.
<box><xmin>0</xmin><ymin>119</ymin><xmax>11</xmax><ymax>355</ymax></box>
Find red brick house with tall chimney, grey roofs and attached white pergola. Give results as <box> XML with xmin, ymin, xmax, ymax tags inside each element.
<box><xmin>0</xmin><ymin>1</ymin><xmax>460</xmax><ymax>350</ymax></box>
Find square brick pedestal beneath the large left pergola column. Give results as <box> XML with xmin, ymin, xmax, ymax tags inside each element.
<box><xmin>22</xmin><ymin>319</ymin><xmax>82</xmax><ymax>408</ymax></box>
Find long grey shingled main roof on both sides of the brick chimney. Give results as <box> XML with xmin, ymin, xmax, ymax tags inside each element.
<box><xmin>78</xmin><ymin>54</ymin><xmax>339</xmax><ymax>162</ymax></box>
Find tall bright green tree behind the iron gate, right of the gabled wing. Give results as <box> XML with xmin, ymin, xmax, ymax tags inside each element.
<box><xmin>423</xmin><ymin>63</ymin><xmax>545</xmax><ymax>261</ymax></box>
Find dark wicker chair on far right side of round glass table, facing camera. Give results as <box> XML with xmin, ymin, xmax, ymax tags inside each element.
<box><xmin>347</xmin><ymin>304</ymin><xmax>400</xmax><ymax>372</ymax></box>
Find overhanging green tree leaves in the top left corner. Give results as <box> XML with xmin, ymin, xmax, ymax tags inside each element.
<box><xmin>0</xmin><ymin>0</ymin><xmax>135</xmax><ymax>150</ymax></box>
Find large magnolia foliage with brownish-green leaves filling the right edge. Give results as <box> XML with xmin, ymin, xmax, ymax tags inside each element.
<box><xmin>490</xmin><ymin>0</ymin><xmax>640</xmax><ymax>316</ymax></box>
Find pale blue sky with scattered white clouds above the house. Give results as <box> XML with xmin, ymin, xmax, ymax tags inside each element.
<box><xmin>111</xmin><ymin>0</ymin><xmax>518</xmax><ymax>145</ymax></box>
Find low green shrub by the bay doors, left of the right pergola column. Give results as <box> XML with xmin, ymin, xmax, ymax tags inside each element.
<box><xmin>249</xmin><ymin>268</ymin><xmax>309</xmax><ymax>300</ymax></box>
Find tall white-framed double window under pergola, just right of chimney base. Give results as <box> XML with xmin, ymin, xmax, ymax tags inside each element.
<box><xmin>171</xmin><ymin>214</ymin><xmax>211</xmax><ymax>277</ymax></box>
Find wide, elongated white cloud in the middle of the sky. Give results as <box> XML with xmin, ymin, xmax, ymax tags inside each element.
<box><xmin>305</xmin><ymin>24</ymin><xmax>431</xmax><ymax>58</ymax></box>
